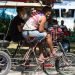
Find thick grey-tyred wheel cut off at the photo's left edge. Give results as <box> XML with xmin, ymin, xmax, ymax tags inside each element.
<box><xmin>0</xmin><ymin>51</ymin><xmax>11</xmax><ymax>75</ymax></box>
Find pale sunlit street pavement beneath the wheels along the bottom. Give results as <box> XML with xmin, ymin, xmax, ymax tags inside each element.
<box><xmin>7</xmin><ymin>66</ymin><xmax>75</xmax><ymax>75</ymax></box>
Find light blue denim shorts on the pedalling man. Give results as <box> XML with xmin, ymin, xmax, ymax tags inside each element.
<box><xmin>22</xmin><ymin>30</ymin><xmax>47</xmax><ymax>40</ymax></box>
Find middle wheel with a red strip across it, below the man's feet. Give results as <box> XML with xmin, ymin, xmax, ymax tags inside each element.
<box><xmin>42</xmin><ymin>58</ymin><xmax>58</xmax><ymax>75</ymax></box>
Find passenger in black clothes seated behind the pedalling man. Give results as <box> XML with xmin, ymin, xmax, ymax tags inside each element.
<box><xmin>9</xmin><ymin>7</ymin><xmax>25</xmax><ymax>41</ymax></box>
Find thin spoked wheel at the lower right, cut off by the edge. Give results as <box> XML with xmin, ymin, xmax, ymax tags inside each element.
<box><xmin>55</xmin><ymin>53</ymin><xmax>75</xmax><ymax>75</ymax></box>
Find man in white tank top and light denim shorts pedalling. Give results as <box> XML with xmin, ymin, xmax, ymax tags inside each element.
<box><xmin>22</xmin><ymin>6</ymin><xmax>56</xmax><ymax>60</ymax></box>
